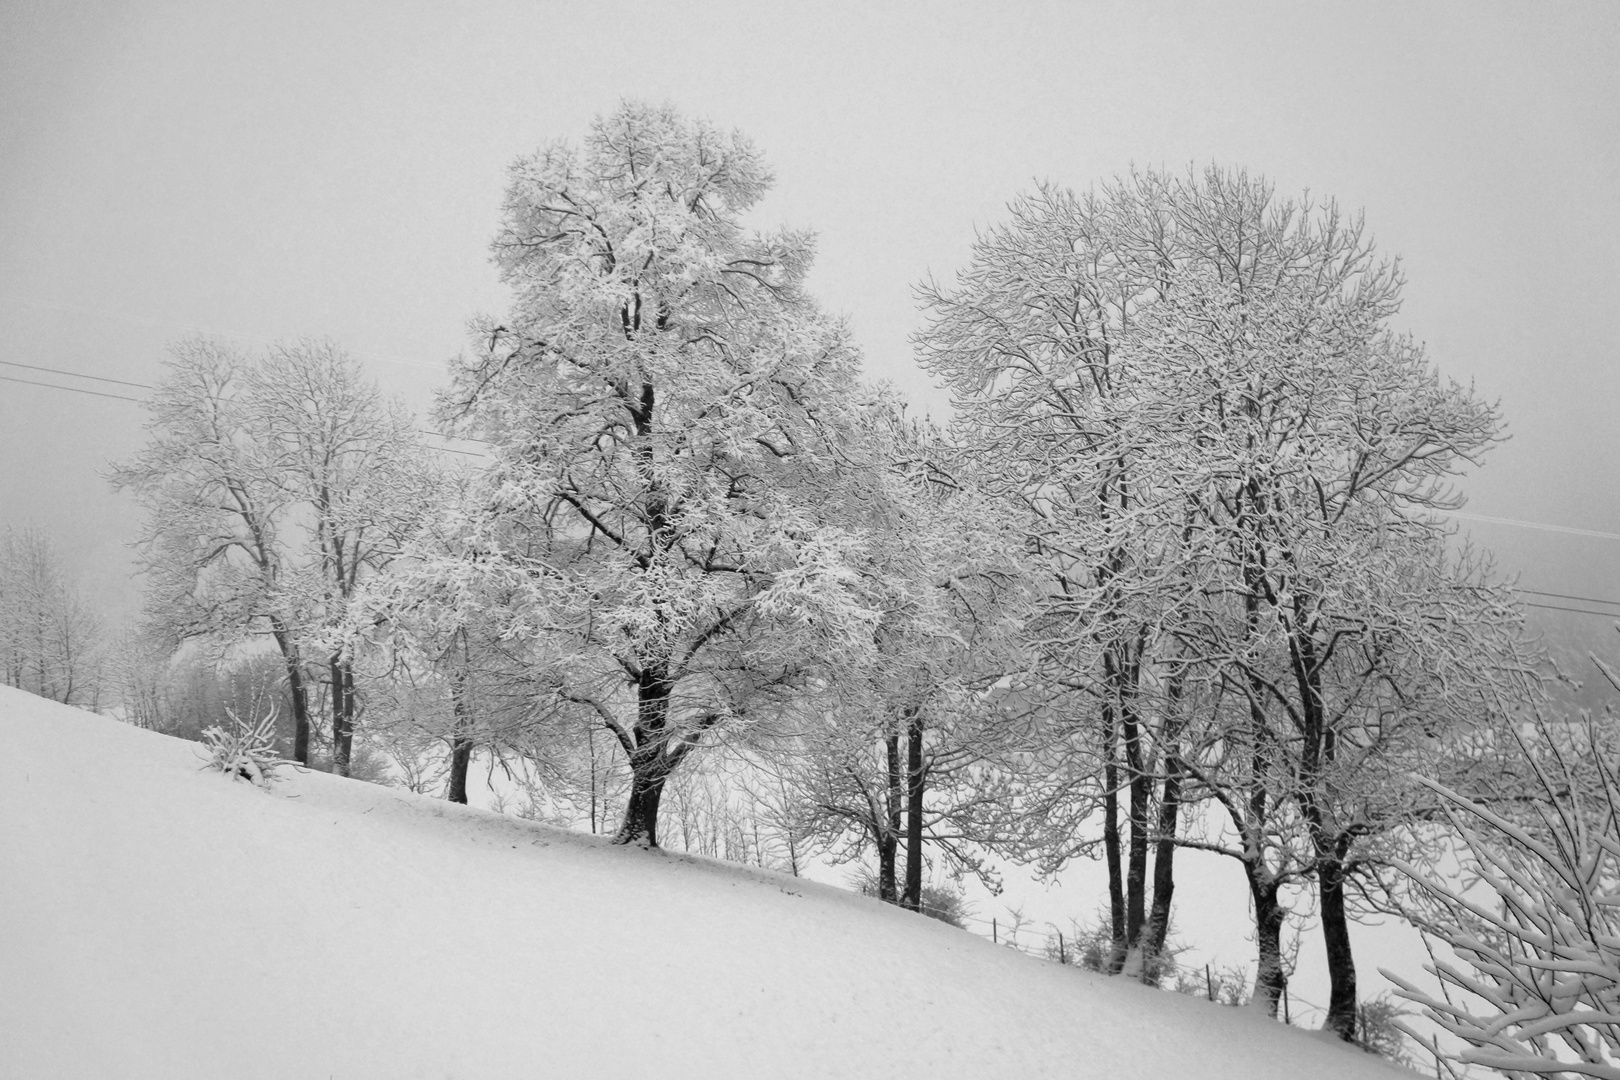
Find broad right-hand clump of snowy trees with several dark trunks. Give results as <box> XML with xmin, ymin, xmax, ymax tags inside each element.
<box><xmin>922</xmin><ymin>168</ymin><xmax>1529</xmax><ymax>1038</ymax></box>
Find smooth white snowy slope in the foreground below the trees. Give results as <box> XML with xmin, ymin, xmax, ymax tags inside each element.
<box><xmin>0</xmin><ymin>687</ymin><xmax>1414</xmax><ymax>1080</ymax></box>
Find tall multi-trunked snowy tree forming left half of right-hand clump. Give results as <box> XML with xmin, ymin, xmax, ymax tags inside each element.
<box><xmin>919</xmin><ymin>173</ymin><xmax>1211</xmax><ymax>970</ymax></box>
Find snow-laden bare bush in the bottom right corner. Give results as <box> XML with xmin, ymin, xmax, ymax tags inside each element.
<box><xmin>1385</xmin><ymin>676</ymin><xmax>1620</xmax><ymax>1080</ymax></box>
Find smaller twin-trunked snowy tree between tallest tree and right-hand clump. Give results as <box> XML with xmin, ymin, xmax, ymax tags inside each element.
<box><xmin>778</xmin><ymin>402</ymin><xmax>1030</xmax><ymax>910</ymax></box>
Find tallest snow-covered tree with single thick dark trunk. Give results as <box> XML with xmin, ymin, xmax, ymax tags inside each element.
<box><xmin>446</xmin><ymin>104</ymin><xmax>872</xmax><ymax>845</ymax></box>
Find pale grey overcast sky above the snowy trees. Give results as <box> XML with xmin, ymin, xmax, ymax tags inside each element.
<box><xmin>0</xmin><ymin>0</ymin><xmax>1620</xmax><ymax>631</ymax></box>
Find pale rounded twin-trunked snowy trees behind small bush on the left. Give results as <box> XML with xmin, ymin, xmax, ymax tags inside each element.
<box><xmin>112</xmin><ymin>340</ymin><xmax>433</xmax><ymax>772</ymax></box>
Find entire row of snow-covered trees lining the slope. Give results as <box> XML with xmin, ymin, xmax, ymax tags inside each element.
<box><xmin>53</xmin><ymin>104</ymin><xmax>1620</xmax><ymax>1062</ymax></box>
